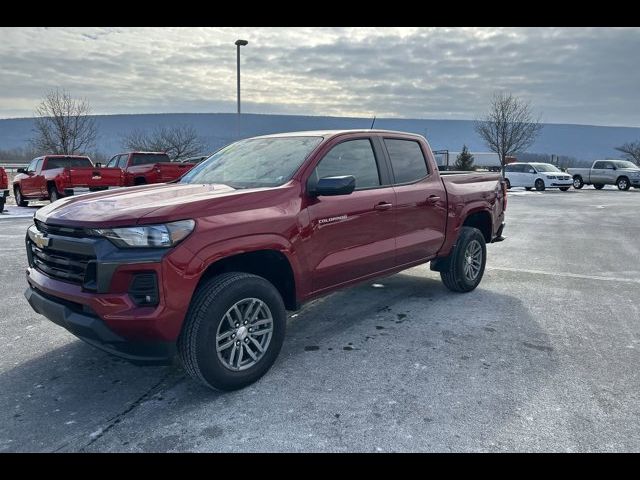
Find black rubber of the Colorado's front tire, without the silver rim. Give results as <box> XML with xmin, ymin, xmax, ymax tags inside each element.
<box><xmin>178</xmin><ymin>272</ymin><xmax>287</xmax><ymax>391</ymax></box>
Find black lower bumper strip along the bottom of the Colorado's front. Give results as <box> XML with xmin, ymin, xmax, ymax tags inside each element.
<box><xmin>24</xmin><ymin>287</ymin><xmax>175</xmax><ymax>365</ymax></box>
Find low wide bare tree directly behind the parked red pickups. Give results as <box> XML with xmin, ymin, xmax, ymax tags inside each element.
<box><xmin>122</xmin><ymin>125</ymin><xmax>206</xmax><ymax>160</ymax></box>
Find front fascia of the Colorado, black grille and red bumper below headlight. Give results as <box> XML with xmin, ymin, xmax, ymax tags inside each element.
<box><xmin>25</xmin><ymin>221</ymin><xmax>199</xmax><ymax>350</ymax></box>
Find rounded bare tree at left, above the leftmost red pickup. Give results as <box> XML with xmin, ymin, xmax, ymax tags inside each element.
<box><xmin>31</xmin><ymin>89</ymin><xmax>97</xmax><ymax>155</ymax></box>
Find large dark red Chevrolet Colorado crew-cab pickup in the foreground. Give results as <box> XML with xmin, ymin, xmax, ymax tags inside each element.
<box><xmin>25</xmin><ymin>130</ymin><xmax>507</xmax><ymax>390</ymax></box>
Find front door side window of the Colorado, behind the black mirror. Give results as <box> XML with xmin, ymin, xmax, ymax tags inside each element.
<box><xmin>315</xmin><ymin>139</ymin><xmax>380</xmax><ymax>189</ymax></box>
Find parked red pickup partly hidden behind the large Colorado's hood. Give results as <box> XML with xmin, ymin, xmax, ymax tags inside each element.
<box><xmin>107</xmin><ymin>152</ymin><xmax>195</xmax><ymax>186</ymax></box>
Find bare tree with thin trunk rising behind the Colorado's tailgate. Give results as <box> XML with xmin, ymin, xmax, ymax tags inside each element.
<box><xmin>474</xmin><ymin>93</ymin><xmax>542</xmax><ymax>175</ymax></box>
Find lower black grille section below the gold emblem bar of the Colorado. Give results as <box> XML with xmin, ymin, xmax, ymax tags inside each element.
<box><xmin>29</xmin><ymin>241</ymin><xmax>95</xmax><ymax>285</ymax></box>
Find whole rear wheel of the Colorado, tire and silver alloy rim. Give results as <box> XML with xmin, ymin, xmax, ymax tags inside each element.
<box><xmin>440</xmin><ymin>227</ymin><xmax>487</xmax><ymax>292</ymax></box>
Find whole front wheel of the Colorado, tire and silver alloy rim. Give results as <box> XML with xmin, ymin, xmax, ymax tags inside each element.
<box><xmin>178</xmin><ymin>272</ymin><xmax>287</xmax><ymax>390</ymax></box>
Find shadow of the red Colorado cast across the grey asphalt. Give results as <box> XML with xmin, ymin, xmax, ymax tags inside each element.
<box><xmin>0</xmin><ymin>267</ymin><xmax>558</xmax><ymax>451</ymax></box>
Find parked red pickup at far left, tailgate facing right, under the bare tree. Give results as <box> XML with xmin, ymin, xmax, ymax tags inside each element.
<box><xmin>13</xmin><ymin>155</ymin><xmax>124</xmax><ymax>207</ymax></box>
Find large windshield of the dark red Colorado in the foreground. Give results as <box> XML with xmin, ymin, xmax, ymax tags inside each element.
<box><xmin>180</xmin><ymin>137</ymin><xmax>322</xmax><ymax>188</ymax></box>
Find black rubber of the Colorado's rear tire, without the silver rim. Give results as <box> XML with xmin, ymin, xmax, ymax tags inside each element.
<box><xmin>440</xmin><ymin>227</ymin><xmax>487</xmax><ymax>292</ymax></box>
